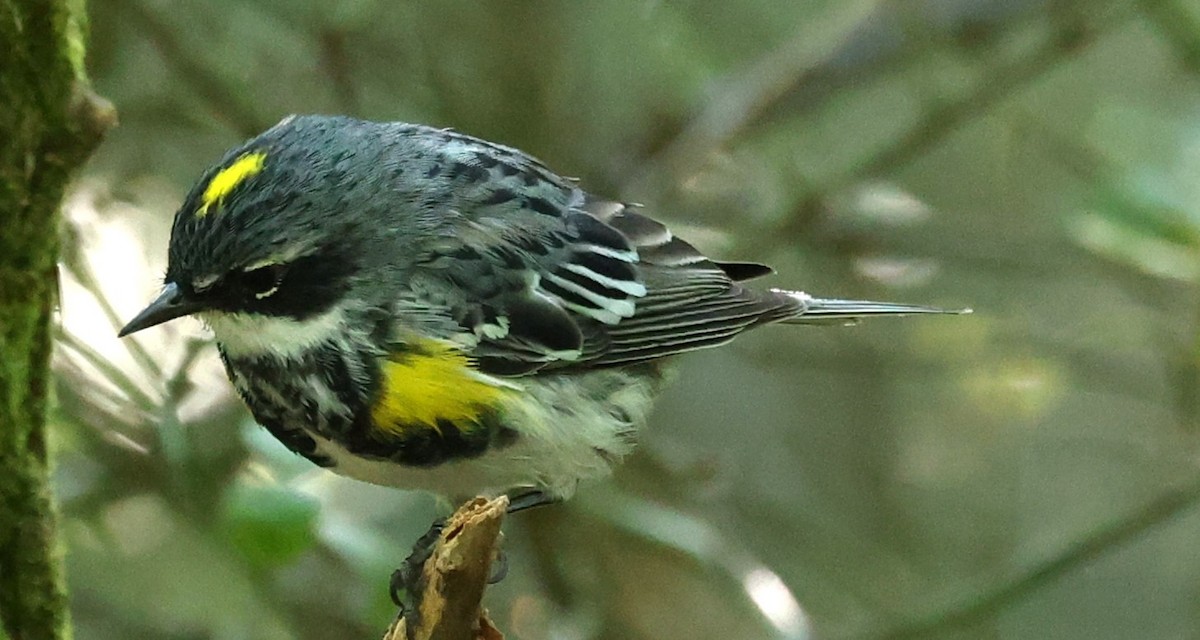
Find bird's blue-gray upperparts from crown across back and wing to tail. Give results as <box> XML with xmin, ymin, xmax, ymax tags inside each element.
<box><xmin>168</xmin><ymin>116</ymin><xmax>960</xmax><ymax>375</ymax></box>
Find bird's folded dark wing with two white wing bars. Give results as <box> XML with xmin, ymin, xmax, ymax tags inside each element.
<box><xmin>408</xmin><ymin>166</ymin><xmax>800</xmax><ymax>375</ymax></box>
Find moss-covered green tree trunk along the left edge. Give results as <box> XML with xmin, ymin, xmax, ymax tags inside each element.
<box><xmin>0</xmin><ymin>0</ymin><xmax>113</xmax><ymax>640</ymax></box>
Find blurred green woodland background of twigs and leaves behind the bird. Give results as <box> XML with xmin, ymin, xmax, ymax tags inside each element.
<box><xmin>53</xmin><ymin>0</ymin><xmax>1200</xmax><ymax>640</ymax></box>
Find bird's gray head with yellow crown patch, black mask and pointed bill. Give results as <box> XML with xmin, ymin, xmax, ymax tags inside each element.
<box><xmin>120</xmin><ymin>118</ymin><xmax>381</xmax><ymax>352</ymax></box>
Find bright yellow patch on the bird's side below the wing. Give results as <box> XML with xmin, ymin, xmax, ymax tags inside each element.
<box><xmin>371</xmin><ymin>340</ymin><xmax>506</xmax><ymax>433</ymax></box>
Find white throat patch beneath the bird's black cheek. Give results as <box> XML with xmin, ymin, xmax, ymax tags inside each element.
<box><xmin>199</xmin><ymin>306</ymin><xmax>346</xmax><ymax>359</ymax></box>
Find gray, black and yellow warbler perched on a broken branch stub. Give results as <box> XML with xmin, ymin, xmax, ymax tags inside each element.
<box><xmin>120</xmin><ymin>116</ymin><xmax>964</xmax><ymax>507</ymax></box>
